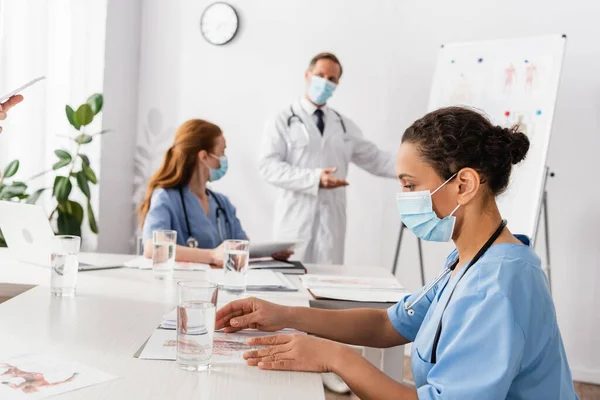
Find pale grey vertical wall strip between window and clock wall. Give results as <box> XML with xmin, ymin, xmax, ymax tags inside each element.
<box><xmin>98</xmin><ymin>0</ymin><xmax>141</xmax><ymax>253</ymax></box>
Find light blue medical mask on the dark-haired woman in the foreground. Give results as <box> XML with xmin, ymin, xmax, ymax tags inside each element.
<box><xmin>396</xmin><ymin>174</ymin><xmax>460</xmax><ymax>242</ymax></box>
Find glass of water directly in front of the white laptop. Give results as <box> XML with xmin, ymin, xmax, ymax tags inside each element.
<box><xmin>50</xmin><ymin>235</ymin><xmax>81</xmax><ymax>297</ymax></box>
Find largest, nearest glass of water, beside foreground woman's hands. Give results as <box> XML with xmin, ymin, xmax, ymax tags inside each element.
<box><xmin>177</xmin><ymin>281</ymin><xmax>219</xmax><ymax>371</ymax></box>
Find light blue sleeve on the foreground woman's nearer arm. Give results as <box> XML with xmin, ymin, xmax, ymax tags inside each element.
<box><xmin>417</xmin><ymin>293</ymin><xmax>525</xmax><ymax>400</ymax></box>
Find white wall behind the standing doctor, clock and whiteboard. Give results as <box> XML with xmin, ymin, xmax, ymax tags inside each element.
<box><xmin>115</xmin><ymin>0</ymin><xmax>600</xmax><ymax>383</ymax></box>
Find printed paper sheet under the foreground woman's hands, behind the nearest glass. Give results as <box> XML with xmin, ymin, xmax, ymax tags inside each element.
<box><xmin>139</xmin><ymin>329</ymin><xmax>304</xmax><ymax>364</ymax></box>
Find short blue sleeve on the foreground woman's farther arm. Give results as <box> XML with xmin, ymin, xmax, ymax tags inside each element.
<box><xmin>387</xmin><ymin>288</ymin><xmax>437</xmax><ymax>342</ymax></box>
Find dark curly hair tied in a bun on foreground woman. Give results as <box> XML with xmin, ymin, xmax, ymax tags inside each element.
<box><xmin>402</xmin><ymin>107</ymin><xmax>529</xmax><ymax>196</ymax></box>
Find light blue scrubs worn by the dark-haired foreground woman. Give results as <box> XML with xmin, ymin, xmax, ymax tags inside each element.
<box><xmin>388</xmin><ymin>236</ymin><xmax>578</xmax><ymax>400</ymax></box>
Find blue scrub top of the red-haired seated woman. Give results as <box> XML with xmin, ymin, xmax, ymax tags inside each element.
<box><xmin>143</xmin><ymin>186</ymin><xmax>248</xmax><ymax>249</ymax></box>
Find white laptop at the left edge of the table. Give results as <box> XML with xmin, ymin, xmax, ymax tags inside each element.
<box><xmin>0</xmin><ymin>201</ymin><xmax>124</xmax><ymax>271</ymax></box>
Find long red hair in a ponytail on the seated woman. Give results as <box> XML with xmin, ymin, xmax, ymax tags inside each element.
<box><xmin>138</xmin><ymin>119</ymin><xmax>223</xmax><ymax>225</ymax></box>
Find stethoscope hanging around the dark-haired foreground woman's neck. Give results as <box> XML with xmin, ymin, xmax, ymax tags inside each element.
<box><xmin>404</xmin><ymin>220</ymin><xmax>507</xmax><ymax>364</ymax></box>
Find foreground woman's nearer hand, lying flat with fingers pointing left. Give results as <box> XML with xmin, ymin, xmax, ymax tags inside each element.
<box><xmin>244</xmin><ymin>335</ymin><xmax>345</xmax><ymax>372</ymax></box>
